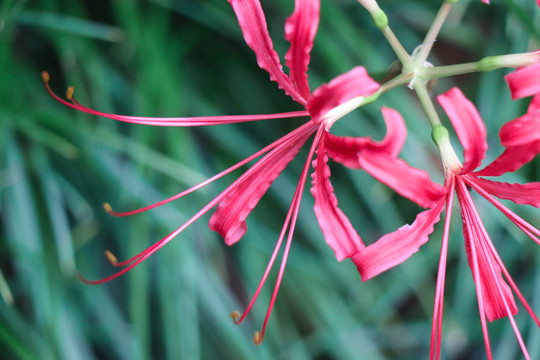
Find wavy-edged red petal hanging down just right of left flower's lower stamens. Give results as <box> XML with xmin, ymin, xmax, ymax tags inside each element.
<box><xmin>311</xmin><ymin>137</ymin><xmax>365</xmax><ymax>261</ymax></box>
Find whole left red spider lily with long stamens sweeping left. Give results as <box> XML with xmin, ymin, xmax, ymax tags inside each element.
<box><xmin>43</xmin><ymin>0</ymin><xmax>418</xmax><ymax>343</ymax></box>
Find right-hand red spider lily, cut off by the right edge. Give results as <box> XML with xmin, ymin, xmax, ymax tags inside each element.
<box><xmin>352</xmin><ymin>88</ymin><xmax>540</xmax><ymax>359</ymax></box>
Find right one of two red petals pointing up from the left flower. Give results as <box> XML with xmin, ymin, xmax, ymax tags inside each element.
<box><xmin>285</xmin><ymin>0</ymin><xmax>320</xmax><ymax>99</ymax></box>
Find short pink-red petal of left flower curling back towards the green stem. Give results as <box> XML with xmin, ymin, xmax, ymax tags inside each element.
<box><xmin>306</xmin><ymin>66</ymin><xmax>379</xmax><ymax>123</ymax></box>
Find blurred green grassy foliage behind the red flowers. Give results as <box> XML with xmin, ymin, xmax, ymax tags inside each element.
<box><xmin>0</xmin><ymin>0</ymin><xmax>540</xmax><ymax>360</ymax></box>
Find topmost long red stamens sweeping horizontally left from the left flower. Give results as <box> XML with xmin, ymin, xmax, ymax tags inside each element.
<box><xmin>41</xmin><ymin>71</ymin><xmax>309</xmax><ymax>126</ymax></box>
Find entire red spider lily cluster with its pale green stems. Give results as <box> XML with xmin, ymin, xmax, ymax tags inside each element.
<box><xmin>42</xmin><ymin>0</ymin><xmax>540</xmax><ymax>358</ymax></box>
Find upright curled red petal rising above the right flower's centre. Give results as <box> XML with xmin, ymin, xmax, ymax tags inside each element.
<box><xmin>437</xmin><ymin>88</ymin><xmax>487</xmax><ymax>174</ymax></box>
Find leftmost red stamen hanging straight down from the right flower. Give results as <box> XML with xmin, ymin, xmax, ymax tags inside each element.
<box><xmin>429</xmin><ymin>176</ymin><xmax>455</xmax><ymax>360</ymax></box>
